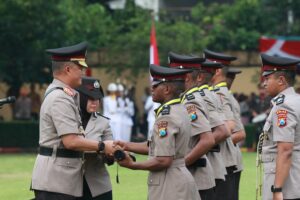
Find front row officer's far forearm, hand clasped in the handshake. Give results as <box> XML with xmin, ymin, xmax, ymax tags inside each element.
<box><xmin>113</xmin><ymin>140</ymin><xmax>149</xmax><ymax>155</ymax></box>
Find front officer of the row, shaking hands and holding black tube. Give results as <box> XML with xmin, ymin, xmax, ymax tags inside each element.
<box><xmin>117</xmin><ymin>65</ymin><xmax>200</xmax><ymax>200</ymax></box>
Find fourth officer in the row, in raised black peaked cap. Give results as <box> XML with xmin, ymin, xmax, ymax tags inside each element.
<box><xmin>204</xmin><ymin>49</ymin><xmax>237</xmax><ymax>200</ymax></box>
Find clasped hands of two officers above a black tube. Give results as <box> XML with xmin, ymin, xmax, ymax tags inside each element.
<box><xmin>99</xmin><ymin>140</ymin><xmax>136</xmax><ymax>162</ymax></box>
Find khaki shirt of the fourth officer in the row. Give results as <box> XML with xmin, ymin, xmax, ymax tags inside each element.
<box><xmin>214</xmin><ymin>82</ymin><xmax>237</xmax><ymax>167</ymax></box>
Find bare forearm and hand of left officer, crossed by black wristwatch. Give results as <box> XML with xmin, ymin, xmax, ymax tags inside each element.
<box><xmin>61</xmin><ymin>134</ymin><xmax>114</xmax><ymax>154</ymax></box>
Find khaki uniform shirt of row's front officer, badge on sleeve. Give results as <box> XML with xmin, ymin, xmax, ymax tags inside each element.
<box><xmin>148</xmin><ymin>99</ymin><xmax>200</xmax><ymax>200</ymax></box>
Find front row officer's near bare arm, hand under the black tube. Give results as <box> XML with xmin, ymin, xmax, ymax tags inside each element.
<box><xmin>119</xmin><ymin>154</ymin><xmax>173</xmax><ymax>171</ymax></box>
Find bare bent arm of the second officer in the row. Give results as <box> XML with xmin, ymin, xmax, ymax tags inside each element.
<box><xmin>185</xmin><ymin>132</ymin><xmax>215</xmax><ymax>166</ymax></box>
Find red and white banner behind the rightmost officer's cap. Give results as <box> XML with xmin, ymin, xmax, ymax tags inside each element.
<box><xmin>259</xmin><ymin>36</ymin><xmax>300</xmax><ymax>59</ymax></box>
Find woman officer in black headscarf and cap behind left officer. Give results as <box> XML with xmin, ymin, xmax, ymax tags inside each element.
<box><xmin>76</xmin><ymin>77</ymin><xmax>114</xmax><ymax>200</ymax></box>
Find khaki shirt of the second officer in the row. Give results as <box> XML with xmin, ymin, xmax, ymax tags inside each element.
<box><xmin>182</xmin><ymin>87</ymin><xmax>216</xmax><ymax>190</ymax></box>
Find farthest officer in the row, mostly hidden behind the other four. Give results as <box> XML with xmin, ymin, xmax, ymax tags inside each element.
<box><xmin>226</xmin><ymin>67</ymin><xmax>246</xmax><ymax>200</ymax></box>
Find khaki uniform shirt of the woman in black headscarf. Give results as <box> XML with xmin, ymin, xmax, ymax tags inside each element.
<box><xmin>84</xmin><ymin>113</ymin><xmax>113</xmax><ymax>197</ymax></box>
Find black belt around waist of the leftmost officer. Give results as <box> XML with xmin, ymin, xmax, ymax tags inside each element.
<box><xmin>39</xmin><ymin>147</ymin><xmax>83</xmax><ymax>158</ymax></box>
